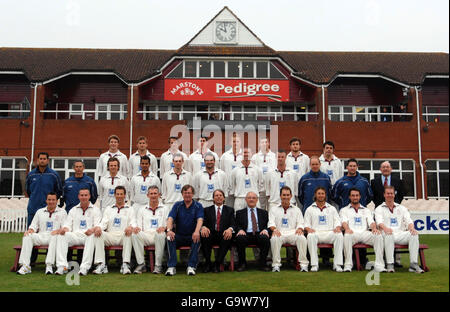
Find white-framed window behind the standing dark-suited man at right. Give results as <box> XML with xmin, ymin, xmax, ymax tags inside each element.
<box><xmin>344</xmin><ymin>159</ymin><xmax>418</xmax><ymax>198</ymax></box>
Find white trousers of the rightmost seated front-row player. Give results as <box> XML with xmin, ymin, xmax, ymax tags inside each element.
<box><xmin>383</xmin><ymin>231</ymin><xmax>419</xmax><ymax>264</ymax></box>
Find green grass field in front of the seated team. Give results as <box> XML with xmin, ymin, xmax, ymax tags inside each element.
<box><xmin>0</xmin><ymin>233</ymin><xmax>449</xmax><ymax>292</ymax></box>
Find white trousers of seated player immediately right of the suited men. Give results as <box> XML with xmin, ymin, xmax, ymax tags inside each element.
<box><xmin>270</xmin><ymin>234</ymin><xmax>309</xmax><ymax>267</ymax></box>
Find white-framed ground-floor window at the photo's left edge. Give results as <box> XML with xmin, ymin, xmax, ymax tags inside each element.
<box><xmin>0</xmin><ymin>157</ymin><xmax>28</xmax><ymax>197</ymax></box>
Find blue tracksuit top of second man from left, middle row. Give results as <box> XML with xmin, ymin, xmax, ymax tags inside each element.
<box><xmin>62</xmin><ymin>173</ymin><xmax>98</xmax><ymax>212</ymax></box>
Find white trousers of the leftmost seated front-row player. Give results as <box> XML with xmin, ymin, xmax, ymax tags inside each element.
<box><xmin>19</xmin><ymin>232</ymin><xmax>58</xmax><ymax>266</ymax></box>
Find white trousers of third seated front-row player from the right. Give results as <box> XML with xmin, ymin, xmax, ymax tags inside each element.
<box><xmin>307</xmin><ymin>231</ymin><xmax>344</xmax><ymax>266</ymax></box>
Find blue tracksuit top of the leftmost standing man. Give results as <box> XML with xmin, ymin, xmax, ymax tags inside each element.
<box><xmin>25</xmin><ymin>166</ymin><xmax>63</xmax><ymax>213</ymax></box>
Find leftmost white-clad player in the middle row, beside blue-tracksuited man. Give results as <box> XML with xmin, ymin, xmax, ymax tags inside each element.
<box><xmin>98</xmin><ymin>158</ymin><xmax>130</xmax><ymax>212</ymax></box>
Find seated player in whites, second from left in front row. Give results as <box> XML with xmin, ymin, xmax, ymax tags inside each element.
<box><xmin>56</xmin><ymin>189</ymin><xmax>102</xmax><ymax>275</ymax></box>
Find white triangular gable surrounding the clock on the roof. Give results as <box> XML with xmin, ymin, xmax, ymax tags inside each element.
<box><xmin>189</xmin><ymin>7</ymin><xmax>264</xmax><ymax>47</ymax></box>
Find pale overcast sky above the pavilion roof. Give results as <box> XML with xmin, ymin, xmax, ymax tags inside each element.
<box><xmin>0</xmin><ymin>0</ymin><xmax>449</xmax><ymax>53</ymax></box>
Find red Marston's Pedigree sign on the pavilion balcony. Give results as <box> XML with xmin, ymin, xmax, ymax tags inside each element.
<box><xmin>164</xmin><ymin>79</ymin><xmax>289</xmax><ymax>102</ymax></box>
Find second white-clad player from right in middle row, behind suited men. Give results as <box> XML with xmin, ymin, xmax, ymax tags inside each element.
<box><xmin>230</xmin><ymin>147</ymin><xmax>264</xmax><ymax>212</ymax></box>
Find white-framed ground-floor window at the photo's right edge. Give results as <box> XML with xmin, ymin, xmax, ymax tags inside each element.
<box><xmin>425</xmin><ymin>160</ymin><xmax>449</xmax><ymax>198</ymax></box>
